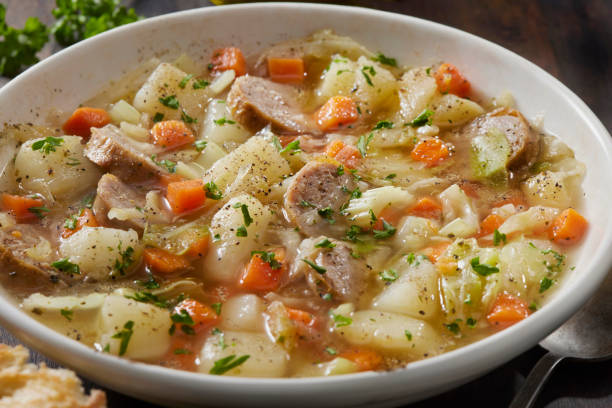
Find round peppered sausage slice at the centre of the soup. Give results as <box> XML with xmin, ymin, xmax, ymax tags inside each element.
<box><xmin>285</xmin><ymin>161</ymin><xmax>357</xmax><ymax>236</ymax></box>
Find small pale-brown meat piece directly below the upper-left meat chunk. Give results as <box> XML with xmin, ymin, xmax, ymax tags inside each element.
<box><xmin>93</xmin><ymin>173</ymin><xmax>146</xmax><ymax>230</ymax></box>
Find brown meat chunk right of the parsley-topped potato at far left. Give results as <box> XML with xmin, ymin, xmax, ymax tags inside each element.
<box><xmin>85</xmin><ymin>125</ymin><xmax>165</xmax><ymax>181</ymax></box>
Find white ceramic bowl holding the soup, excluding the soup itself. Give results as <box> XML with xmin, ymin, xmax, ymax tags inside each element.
<box><xmin>0</xmin><ymin>3</ymin><xmax>612</xmax><ymax>407</ymax></box>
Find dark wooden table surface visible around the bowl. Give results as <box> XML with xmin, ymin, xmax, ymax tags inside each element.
<box><xmin>0</xmin><ymin>0</ymin><xmax>612</xmax><ymax>408</ymax></box>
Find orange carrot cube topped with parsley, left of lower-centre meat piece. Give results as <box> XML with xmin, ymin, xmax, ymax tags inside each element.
<box><xmin>239</xmin><ymin>248</ymin><xmax>285</xmax><ymax>292</ymax></box>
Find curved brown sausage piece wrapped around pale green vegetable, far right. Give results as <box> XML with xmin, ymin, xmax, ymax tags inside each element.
<box><xmin>461</xmin><ymin>108</ymin><xmax>540</xmax><ymax>169</ymax></box>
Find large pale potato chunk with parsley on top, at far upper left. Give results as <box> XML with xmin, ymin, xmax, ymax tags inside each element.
<box><xmin>15</xmin><ymin>136</ymin><xmax>101</xmax><ymax>198</ymax></box>
